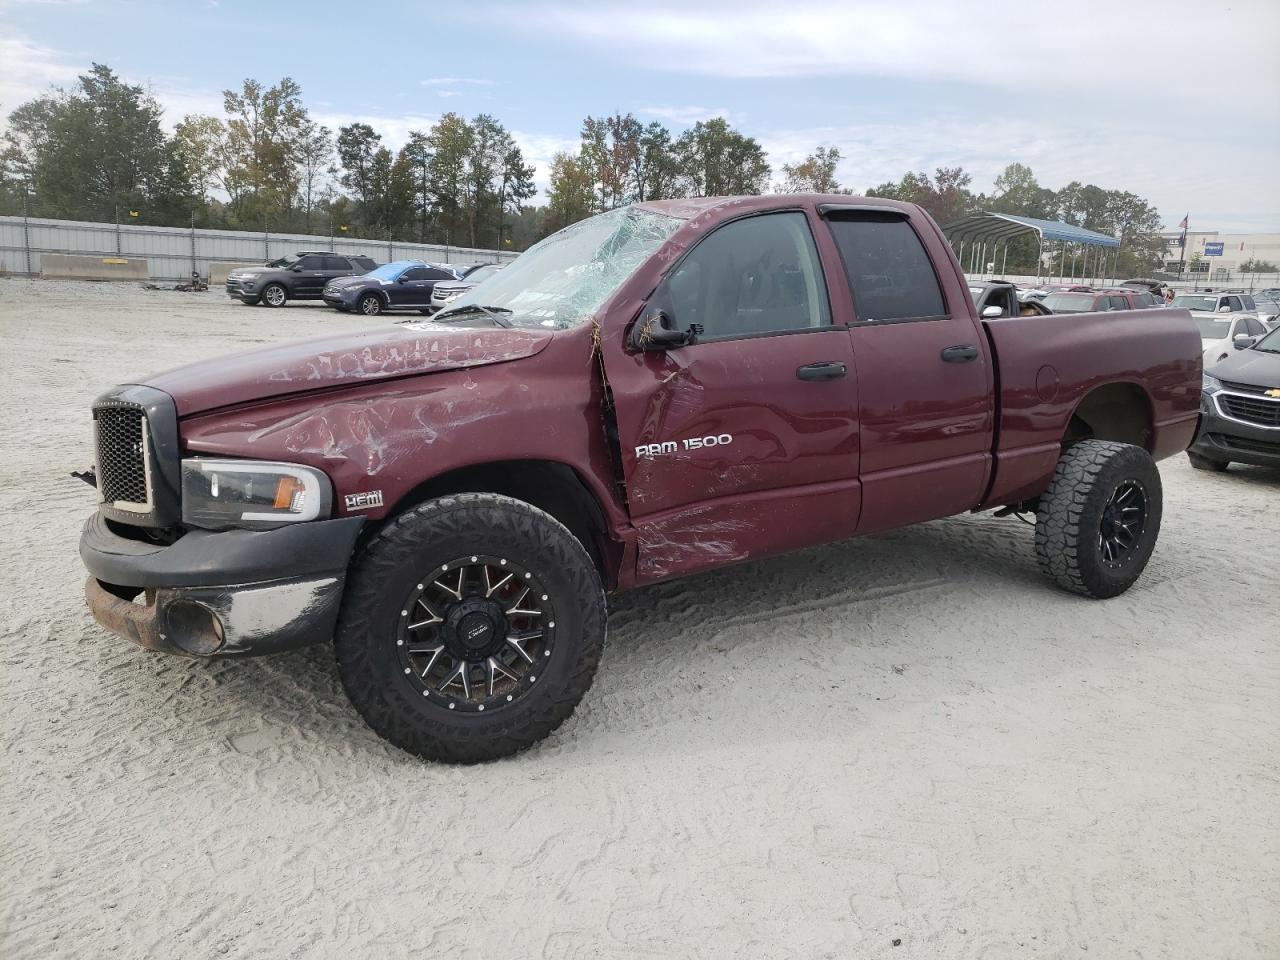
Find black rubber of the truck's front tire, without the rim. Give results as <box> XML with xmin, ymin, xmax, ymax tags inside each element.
<box><xmin>334</xmin><ymin>493</ymin><xmax>605</xmax><ymax>763</ymax></box>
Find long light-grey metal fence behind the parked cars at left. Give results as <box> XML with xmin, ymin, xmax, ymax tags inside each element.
<box><xmin>0</xmin><ymin>216</ymin><xmax>518</xmax><ymax>280</ymax></box>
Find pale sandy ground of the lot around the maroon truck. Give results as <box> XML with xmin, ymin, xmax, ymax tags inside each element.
<box><xmin>0</xmin><ymin>279</ymin><xmax>1280</xmax><ymax>960</ymax></box>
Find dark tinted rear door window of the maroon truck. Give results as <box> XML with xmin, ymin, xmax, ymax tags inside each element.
<box><xmin>831</xmin><ymin>215</ymin><xmax>947</xmax><ymax>320</ymax></box>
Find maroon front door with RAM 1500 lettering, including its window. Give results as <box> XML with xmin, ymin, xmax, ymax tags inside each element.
<box><xmin>605</xmin><ymin>210</ymin><xmax>858</xmax><ymax>581</ymax></box>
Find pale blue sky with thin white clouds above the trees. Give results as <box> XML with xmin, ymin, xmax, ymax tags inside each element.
<box><xmin>0</xmin><ymin>0</ymin><xmax>1280</xmax><ymax>233</ymax></box>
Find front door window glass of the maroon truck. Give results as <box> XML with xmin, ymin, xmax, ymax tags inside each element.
<box><xmin>658</xmin><ymin>212</ymin><xmax>831</xmax><ymax>339</ymax></box>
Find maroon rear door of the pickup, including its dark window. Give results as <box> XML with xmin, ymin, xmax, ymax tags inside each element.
<box><xmin>823</xmin><ymin>205</ymin><xmax>998</xmax><ymax>532</ymax></box>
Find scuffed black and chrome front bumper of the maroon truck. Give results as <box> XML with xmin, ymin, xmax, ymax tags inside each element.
<box><xmin>81</xmin><ymin>513</ymin><xmax>364</xmax><ymax>657</ymax></box>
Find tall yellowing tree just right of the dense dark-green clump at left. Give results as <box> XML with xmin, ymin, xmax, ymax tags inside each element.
<box><xmin>223</xmin><ymin>77</ymin><xmax>308</xmax><ymax>224</ymax></box>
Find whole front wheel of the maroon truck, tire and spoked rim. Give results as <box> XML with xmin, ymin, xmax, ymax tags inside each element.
<box><xmin>334</xmin><ymin>494</ymin><xmax>605</xmax><ymax>763</ymax></box>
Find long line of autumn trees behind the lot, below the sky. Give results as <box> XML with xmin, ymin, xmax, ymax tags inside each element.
<box><xmin>0</xmin><ymin>64</ymin><xmax>1166</xmax><ymax>274</ymax></box>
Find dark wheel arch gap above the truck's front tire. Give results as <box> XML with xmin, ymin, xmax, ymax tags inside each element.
<box><xmin>379</xmin><ymin>460</ymin><xmax>621</xmax><ymax>589</ymax></box>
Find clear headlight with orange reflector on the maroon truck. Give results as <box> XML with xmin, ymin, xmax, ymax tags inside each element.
<box><xmin>182</xmin><ymin>457</ymin><xmax>333</xmax><ymax>530</ymax></box>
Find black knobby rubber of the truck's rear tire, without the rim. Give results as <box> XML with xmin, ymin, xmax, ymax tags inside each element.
<box><xmin>1036</xmin><ymin>440</ymin><xmax>1162</xmax><ymax>599</ymax></box>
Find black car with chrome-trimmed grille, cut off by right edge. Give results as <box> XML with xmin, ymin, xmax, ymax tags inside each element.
<box><xmin>1187</xmin><ymin>330</ymin><xmax>1280</xmax><ymax>471</ymax></box>
